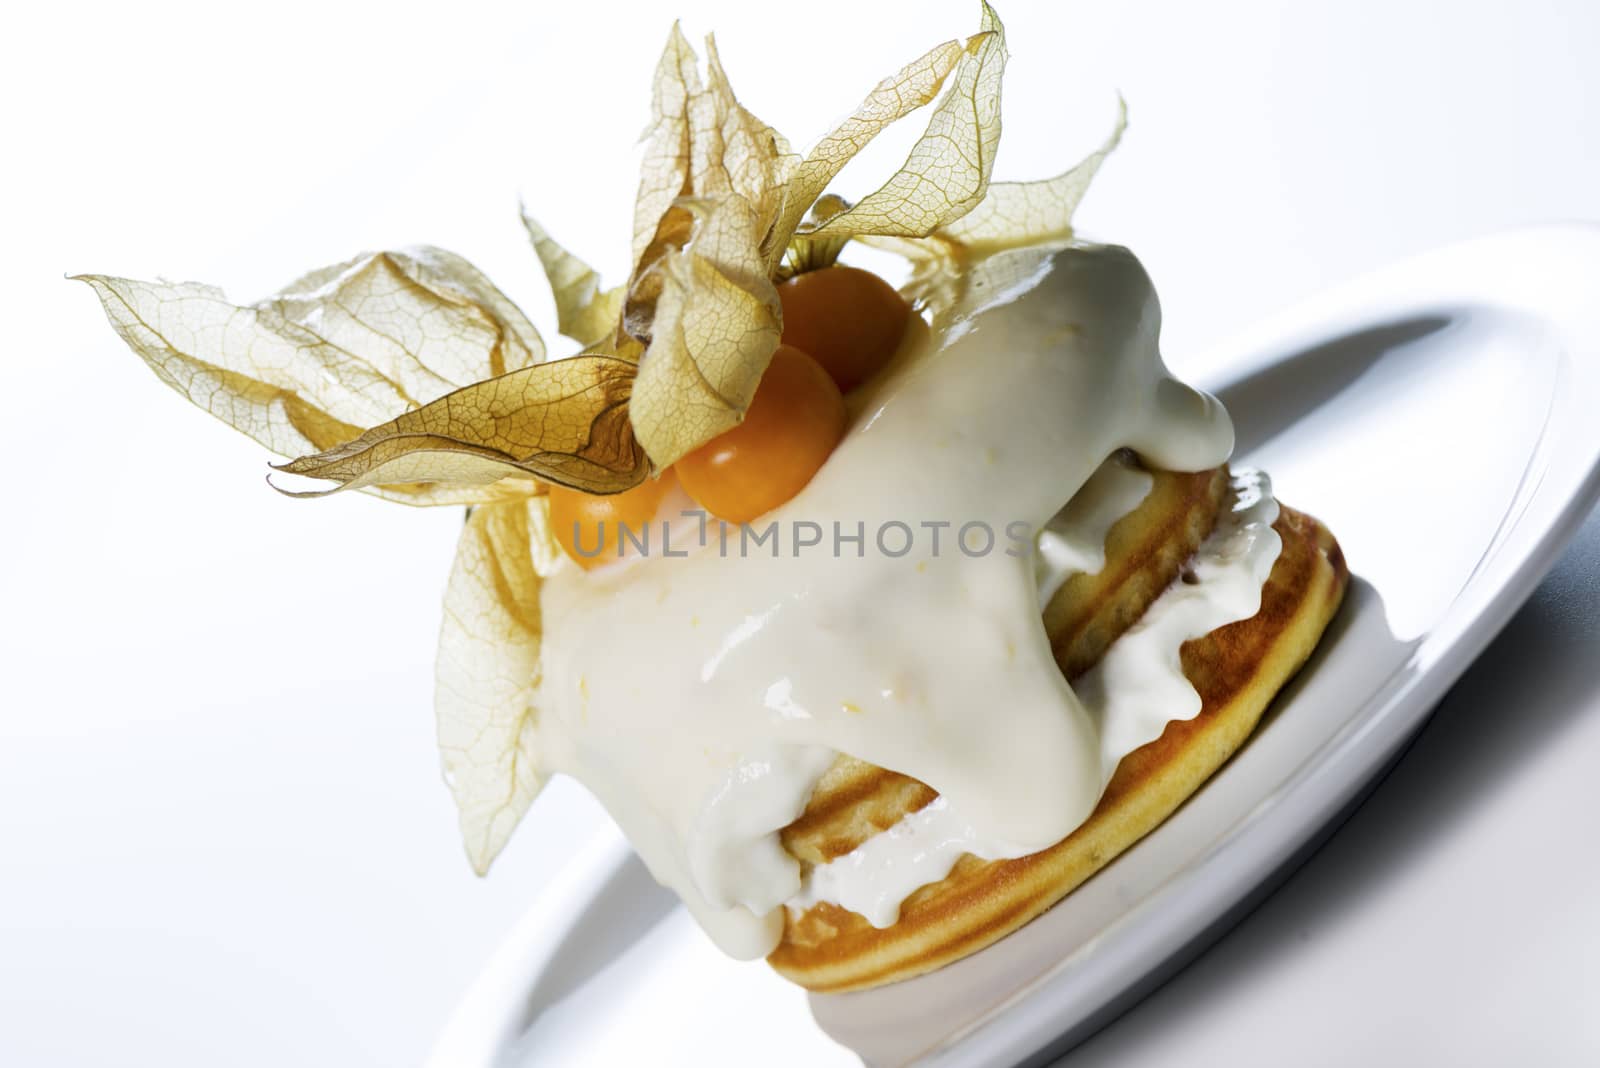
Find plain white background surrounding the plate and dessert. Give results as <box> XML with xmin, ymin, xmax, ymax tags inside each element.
<box><xmin>0</xmin><ymin>0</ymin><xmax>1600</xmax><ymax>1066</ymax></box>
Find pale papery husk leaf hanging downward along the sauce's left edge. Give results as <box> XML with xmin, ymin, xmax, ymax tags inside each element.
<box><xmin>434</xmin><ymin>499</ymin><xmax>546</xmax><ymax>875</ymax></box>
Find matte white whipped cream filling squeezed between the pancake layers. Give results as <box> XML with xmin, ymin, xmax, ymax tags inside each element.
<box><xmin>789</xmin><ymin>472</ymin><xmax>1283</xmax><ymax>927</ymax></box>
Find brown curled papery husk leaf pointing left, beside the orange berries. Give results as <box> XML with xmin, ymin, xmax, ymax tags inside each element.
<box><xmin>278</xmin><ymin>355</ymin><xmax>650</xmax><ymax>496</ymax></box>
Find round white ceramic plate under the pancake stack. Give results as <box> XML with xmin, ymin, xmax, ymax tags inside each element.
<box><xmin>434</xmin><ymin>227</ymin><xmax>1600</xmax><ymax>1068</ymax></box>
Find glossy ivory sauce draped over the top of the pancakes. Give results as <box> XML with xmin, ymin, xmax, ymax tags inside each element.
<box><xmin>538</xmin><ymin>246</ymin><xmax>1235</xmax><ymax>958</ymax></box>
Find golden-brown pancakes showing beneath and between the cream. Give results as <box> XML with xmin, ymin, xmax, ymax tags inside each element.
<box><xmin>768</xmin><ymin>468</ymin><xmax>1349</xmax><ymax>991</ymax></box>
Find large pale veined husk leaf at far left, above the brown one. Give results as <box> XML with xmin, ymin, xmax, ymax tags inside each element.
<box><xmin>82</xmin><ymin>248</ymin><xmax>544</xmax><ymax>504</ymax></box>
